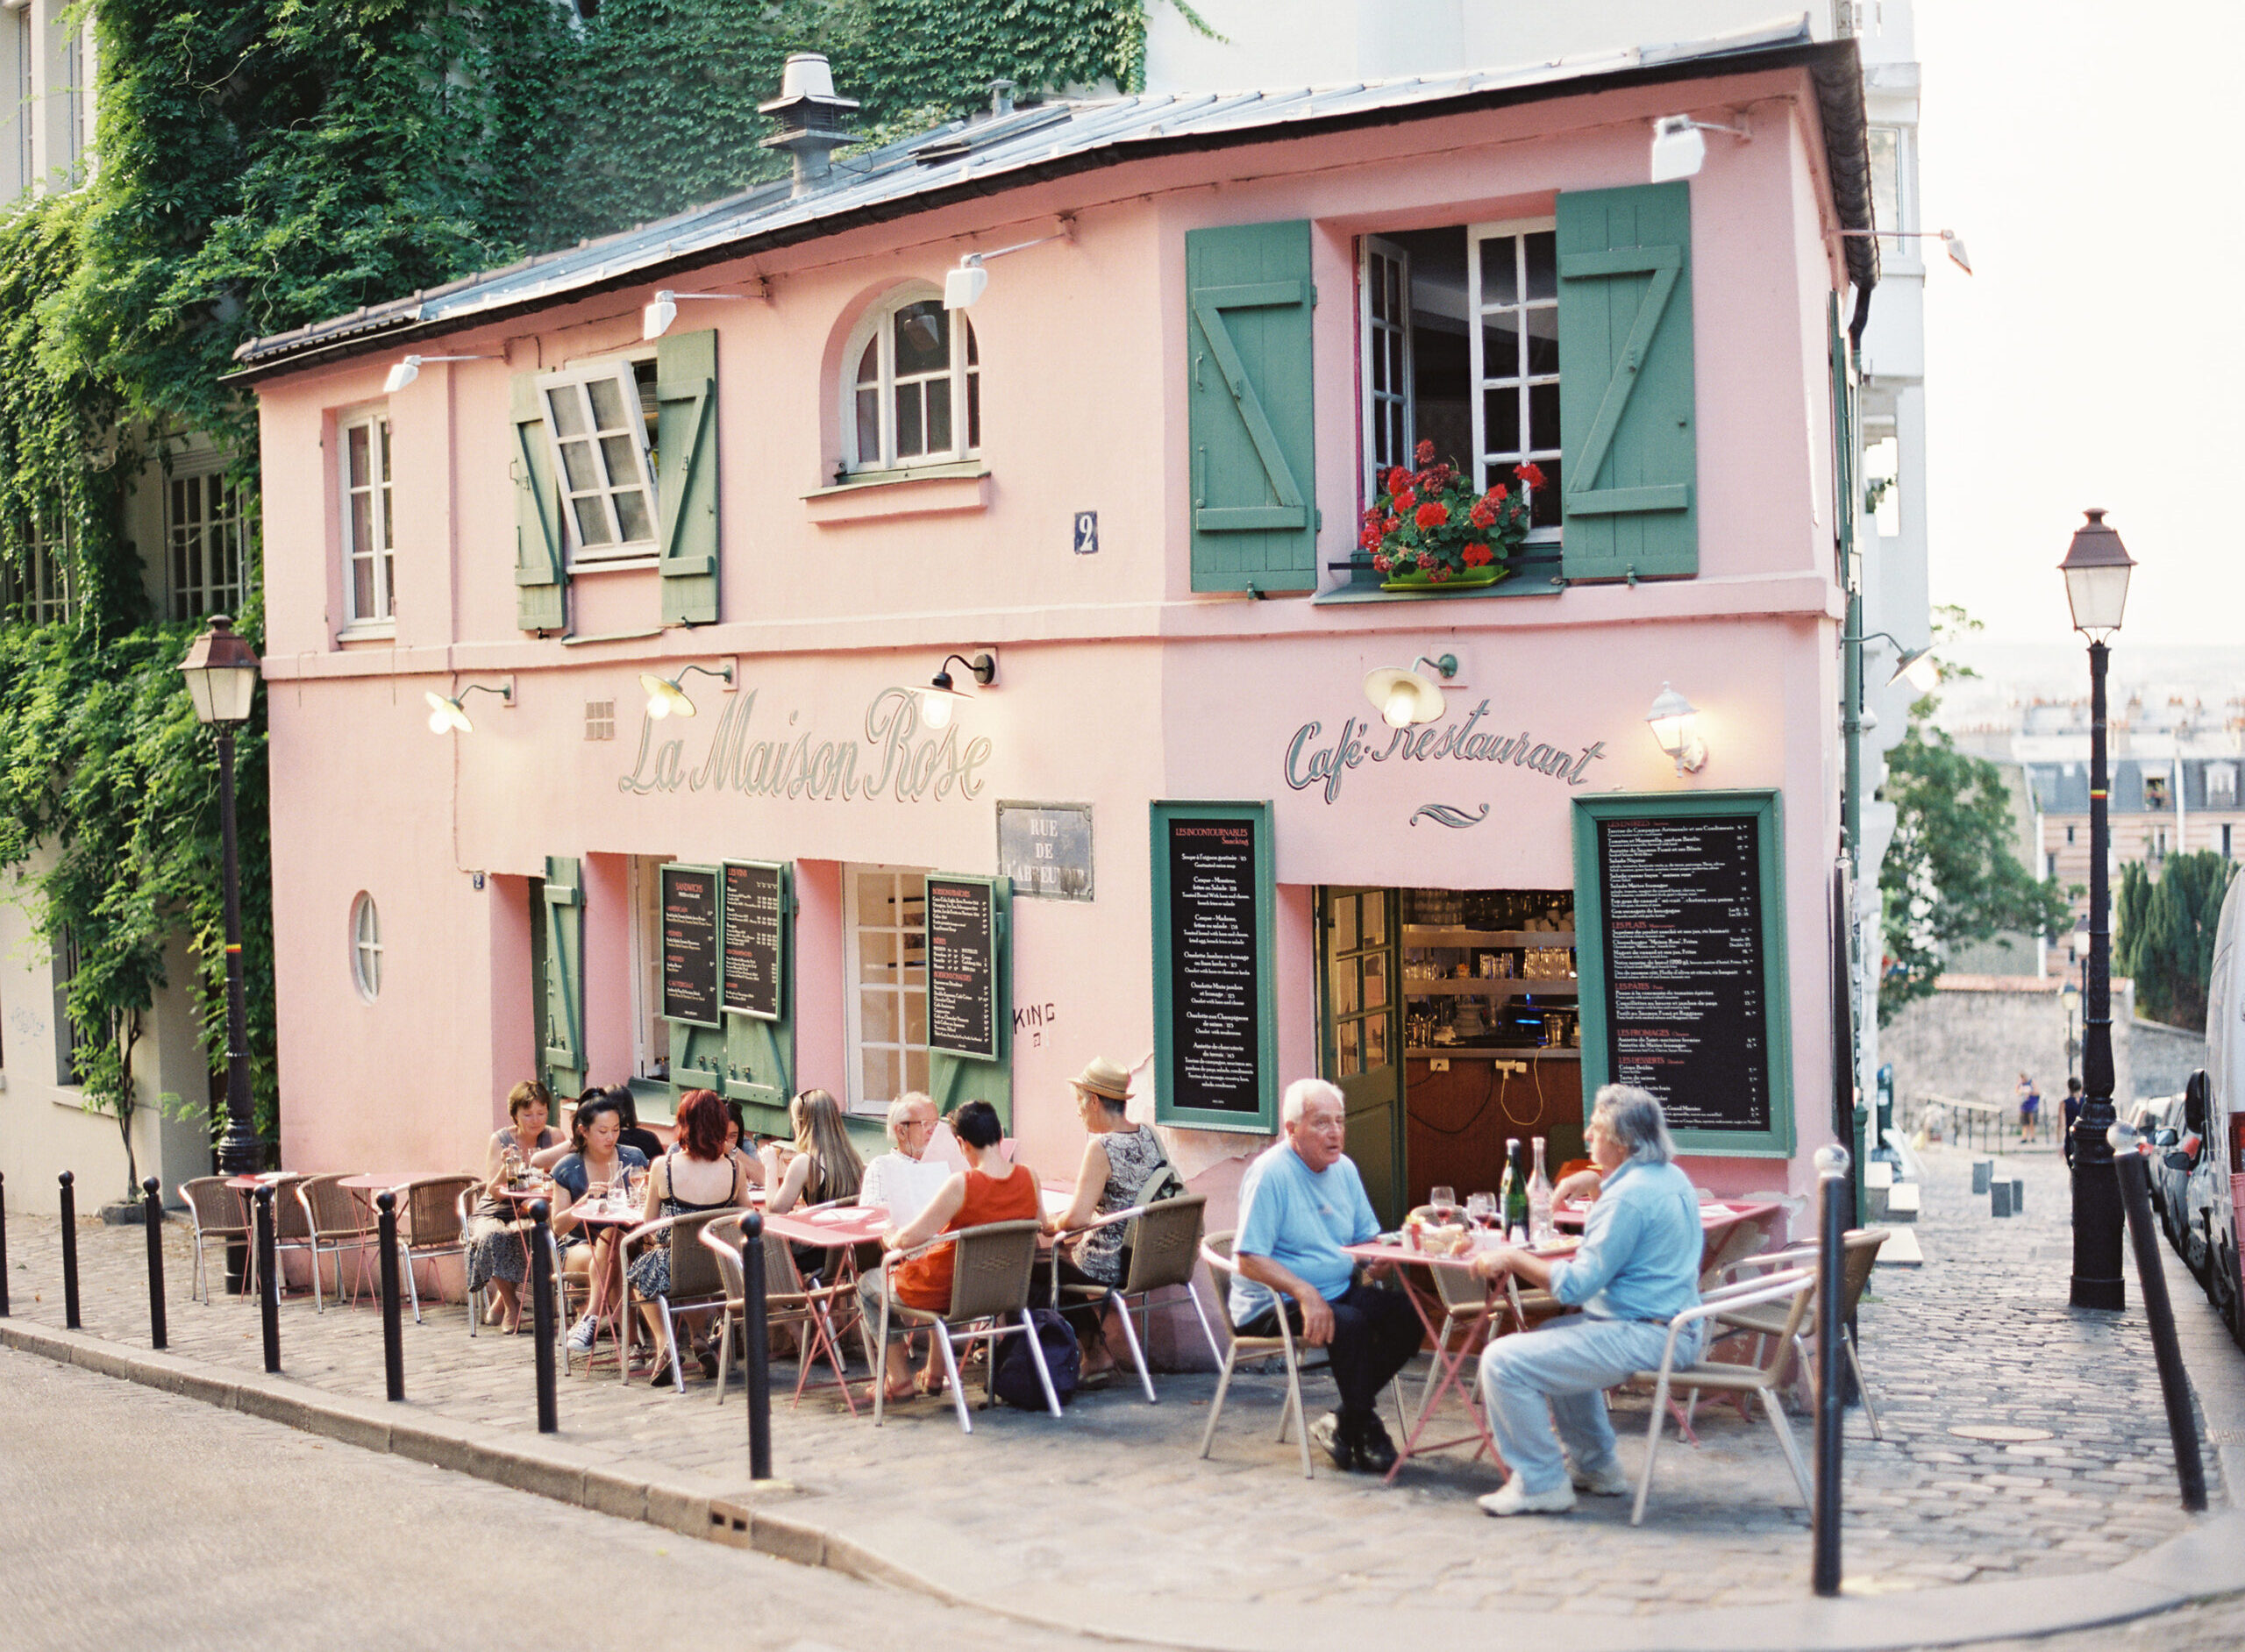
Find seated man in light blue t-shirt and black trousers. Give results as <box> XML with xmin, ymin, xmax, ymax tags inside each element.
<box><xmin>1230</xmin><ymin>1078</ymin><xmax>1421</xmax><ymax>1475</ymax></box>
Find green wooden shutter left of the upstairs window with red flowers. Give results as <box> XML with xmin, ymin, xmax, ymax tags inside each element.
<box><xmin>1186</xmin><ymin>217</ymin><xmax>1318</xmax><ymax>590</ymax></box>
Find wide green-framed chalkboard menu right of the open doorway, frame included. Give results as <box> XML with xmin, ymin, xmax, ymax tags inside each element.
<box><xmin>1579</xmin><ymin>794</ymin><xmax>1792</xmax><ymax>1147</ymax></box>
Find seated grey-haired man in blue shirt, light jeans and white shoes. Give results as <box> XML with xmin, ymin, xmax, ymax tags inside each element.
<box><xmin>1472</xmin><ymin>1084</ymin><xmax>1701</xmax><ymax>1515</ymax></box>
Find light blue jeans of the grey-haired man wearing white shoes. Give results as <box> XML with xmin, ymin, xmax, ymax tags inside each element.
<box><xmin>1482</xmin><ymin>1313</ymin><xmax>1701</xmax><ymax>1492</ymax></box>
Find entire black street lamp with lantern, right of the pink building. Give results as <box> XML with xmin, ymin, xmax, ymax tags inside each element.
<box><xmin>2059</xmin><ymin>509</ymin><xmax>2135</xmax><ymax>1308</ymax></box>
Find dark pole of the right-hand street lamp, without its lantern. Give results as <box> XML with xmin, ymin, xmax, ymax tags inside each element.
<box><xmin>2070</xmin><ymin>642</ymin><xmax>2128</xmax><ymax>1308</ymax></box>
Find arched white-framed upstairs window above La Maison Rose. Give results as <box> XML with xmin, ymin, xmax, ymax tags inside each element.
<box><xmin>842</xmin><ymin>288</ymin><xmax>981</xmax><ymax>472</ymax></box>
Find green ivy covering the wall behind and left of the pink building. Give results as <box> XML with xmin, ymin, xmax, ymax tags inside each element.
<box><xmin>0</xmin><ymin>0</ymin><xmax>1196</xmax><ymax>1136</ymax></box>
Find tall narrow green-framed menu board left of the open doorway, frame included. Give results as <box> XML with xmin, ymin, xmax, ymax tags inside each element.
<box><xmin>1154</xmin><ymin>803</ymin><xmax>1275</xmax><ymax>1127</ymax></box>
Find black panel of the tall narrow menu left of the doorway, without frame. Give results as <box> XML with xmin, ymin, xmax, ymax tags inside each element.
<box><xmin>1170</xmin><ymin>819</ymin><xmax>1264</xmax><ymax>1114</ymax></box>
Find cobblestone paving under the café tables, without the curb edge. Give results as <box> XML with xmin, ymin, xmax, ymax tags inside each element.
<box><xmin>9</xmin><ymin>1150</ymin><xmax>2227</xmax><ymax>1620</ymax></box>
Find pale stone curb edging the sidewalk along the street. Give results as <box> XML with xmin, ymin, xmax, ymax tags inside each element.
<box><xmin>0</xmin><ymin>1320</ymin><xmax>2245</xmax><ymax>1652</ymax></box>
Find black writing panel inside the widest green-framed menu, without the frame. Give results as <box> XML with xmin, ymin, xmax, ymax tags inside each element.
<box><xmin>1599</xmin><ymin>817</ymin><xmax>1771</xmax><ymax>1131</ymax></box>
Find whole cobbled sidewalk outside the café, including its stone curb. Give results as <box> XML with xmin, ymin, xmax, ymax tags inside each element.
<box><xmin>0</xmin><ymin>1150</ymin><xmax>2245</xmax><ymax>1652</ymax></box>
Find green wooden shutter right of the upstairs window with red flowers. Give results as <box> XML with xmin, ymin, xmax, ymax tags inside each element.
<box><xmin>1558</xmin><ymin>182</ymin><xmax>1700</xmax><ymax>579</ymax></box>
